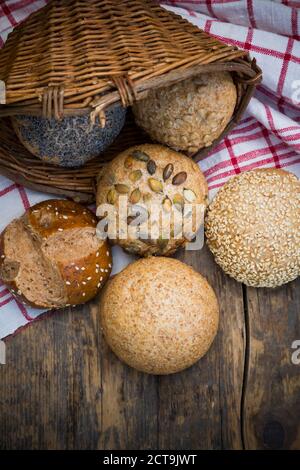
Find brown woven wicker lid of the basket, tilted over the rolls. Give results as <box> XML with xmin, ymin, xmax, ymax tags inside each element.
<box><xmin>0</xmin><ymin>0</ymin><xmax>260</xmax><ymax>120</ymax></box>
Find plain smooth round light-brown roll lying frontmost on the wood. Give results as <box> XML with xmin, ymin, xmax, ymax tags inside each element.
<box><xmin>100</xmin><ymin>257</ymin><xmax>219</xmax><ymax>374</ymax></box>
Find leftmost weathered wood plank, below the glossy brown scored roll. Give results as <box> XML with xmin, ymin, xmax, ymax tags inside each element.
<box><xmin>0</xmin><ymin>306</ymin><xmax>102</xmax><ymax>449</ymax></box>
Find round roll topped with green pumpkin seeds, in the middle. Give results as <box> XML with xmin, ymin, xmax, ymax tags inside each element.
<box><xmin>97</xmin><ymin>144</ymin><xmax>208</xmax><ymax>256</ymax></box>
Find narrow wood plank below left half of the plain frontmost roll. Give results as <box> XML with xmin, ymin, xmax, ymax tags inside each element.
<box><xmin>100</xmin><ymin>332</ymin><xmax>158</xmax><ymax>450</ymax></box>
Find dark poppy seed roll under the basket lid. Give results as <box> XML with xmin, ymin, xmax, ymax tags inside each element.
<box><xmin>11</xmin><ymin>105</ymin><xmax>126</xmax><ymax>167</ymax></box>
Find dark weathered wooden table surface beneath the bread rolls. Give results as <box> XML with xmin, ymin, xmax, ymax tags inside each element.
<box><xmin>0</xmin><ymin>244</ymin><xmax>300</xmax><ymax>450</ymax></box>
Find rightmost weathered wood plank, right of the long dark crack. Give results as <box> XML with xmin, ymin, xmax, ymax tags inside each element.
<box><xmin>243</xmin><ymin>279</ymin><xmax>300</xmax><ymax>449</ymax></box>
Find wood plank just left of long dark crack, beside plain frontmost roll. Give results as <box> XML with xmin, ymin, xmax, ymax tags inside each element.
<box><xmin>159</xmin><ymin>247</ymin><xmax>245</xmax><ymax>449</ymax></box>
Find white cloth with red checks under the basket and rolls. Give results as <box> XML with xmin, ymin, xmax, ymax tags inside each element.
<box><xmin>0</xmin><ymin>0</ymin><xmax>300</xmax><ymax>338</ymax></box>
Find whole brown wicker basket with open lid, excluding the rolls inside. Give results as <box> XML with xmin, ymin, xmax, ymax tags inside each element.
<box><xmin>0</xmin><ymin>0</ymin><xmax>261</xmax><ymax>202</ymax></box>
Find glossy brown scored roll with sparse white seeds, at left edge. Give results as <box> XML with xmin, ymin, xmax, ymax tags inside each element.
<box><xmin>0</xmin><ymin>199</ymin><xmax>112</xmax><ymax>308</ymax></box>
